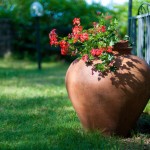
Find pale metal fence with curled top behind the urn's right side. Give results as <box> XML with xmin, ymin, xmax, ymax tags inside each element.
<box><xmin>129</xmin><ymin>3</ymin><xmax>150</xmax><ymax>64</ymax></box>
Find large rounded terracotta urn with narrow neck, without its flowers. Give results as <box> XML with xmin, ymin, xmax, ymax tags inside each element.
<box><xmin>66</xmin><ymin>43</ymin><xmax>150</xmax><ymax>137</ymax></box>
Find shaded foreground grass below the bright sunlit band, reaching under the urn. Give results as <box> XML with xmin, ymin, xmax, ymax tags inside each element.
<box><xmin>0</xmin><ymin>96</ymin><xmax>150</xmax><ymax>150</ymax></box>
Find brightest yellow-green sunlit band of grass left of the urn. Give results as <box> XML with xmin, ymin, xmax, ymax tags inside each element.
<box><xmin>0</xmin><ymin>86</ymin><xmax>67</xmax><ymax>100</ymax></box>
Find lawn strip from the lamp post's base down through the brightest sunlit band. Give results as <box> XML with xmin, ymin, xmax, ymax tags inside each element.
<box><xmin>0</xmin><ymin>61</ymin><xmax>68</xmax><ymax>100</ymax></box>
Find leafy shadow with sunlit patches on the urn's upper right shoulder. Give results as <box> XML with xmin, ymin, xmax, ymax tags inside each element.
<box><xmin>86</xmin><ymin>55</ymin><xmax>147</xmax><ymax>84</ymax></box>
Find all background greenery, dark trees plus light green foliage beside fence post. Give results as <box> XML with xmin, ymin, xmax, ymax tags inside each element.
<box><xmin>0</xmin><ymin>0</ymin><xmax>150</xmax><ymax>60</ymax></box>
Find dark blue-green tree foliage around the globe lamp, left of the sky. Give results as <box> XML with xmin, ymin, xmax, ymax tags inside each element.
<box><xmin>0</xmin><ymin>0</ymin><xmax>108</xmax><ymax>58</ymax></box>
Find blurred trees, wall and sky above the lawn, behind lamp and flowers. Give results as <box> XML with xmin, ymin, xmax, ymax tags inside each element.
<box><xmin>0</xmin><ymin>0</ymin><xmax>150</xmax><ymax>65</ymax></box>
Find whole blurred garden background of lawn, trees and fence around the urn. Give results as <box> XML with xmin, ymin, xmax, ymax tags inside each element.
<box><xmin>0</xmin><ymin>0</ymin><xmax>150</xmax><ymax>150</ymax></box>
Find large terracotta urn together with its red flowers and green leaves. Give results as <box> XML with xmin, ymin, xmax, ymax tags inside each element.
<box><xmin>49</xmin><ymin>14</ymin><xmax>150</xmax><ymax>137</ymax></box>
